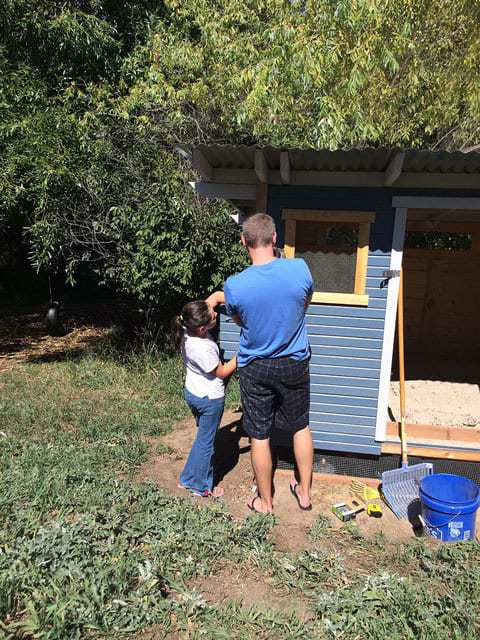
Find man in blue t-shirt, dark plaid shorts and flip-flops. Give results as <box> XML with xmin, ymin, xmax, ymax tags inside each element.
<box><xmin>207</xmin><ymin>213</ymin><xmax>313</xmax><ymax>513</ymax></box>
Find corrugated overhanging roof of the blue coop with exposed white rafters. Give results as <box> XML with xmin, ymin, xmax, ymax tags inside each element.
<box><xmin>178</xmin><ymin>144</ymin><xmax>480</xmax><ymax>209</ymax></box>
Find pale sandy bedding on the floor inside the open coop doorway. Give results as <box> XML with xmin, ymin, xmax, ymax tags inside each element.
<box><xmin>389</xmin><ymin>380</ymin><xmax>480</xmax><ymax>427</ymax></box>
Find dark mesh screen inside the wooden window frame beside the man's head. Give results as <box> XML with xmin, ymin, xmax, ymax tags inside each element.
<box><xmin>295</xmin><ymin>221</ymin><xmax>358</xmax><ymax>293</ymax></box>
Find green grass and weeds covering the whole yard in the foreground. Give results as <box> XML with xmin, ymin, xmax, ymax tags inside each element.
<box><xmin>0</xmin><ymin>353</ymin><xmax>480</xmax><ymax>640</ymax></box>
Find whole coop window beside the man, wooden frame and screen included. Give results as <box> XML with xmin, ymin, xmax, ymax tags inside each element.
<box><xmin>283</xmin><ymin>209</ymin><xmax>375</xmax><ymax>306</ymax></box>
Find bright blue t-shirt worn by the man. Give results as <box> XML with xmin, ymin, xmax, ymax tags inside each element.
<box><xmin>224</xmin><ymin>258</ymin><xmax>313</xmax><ymax>367</ymax></box>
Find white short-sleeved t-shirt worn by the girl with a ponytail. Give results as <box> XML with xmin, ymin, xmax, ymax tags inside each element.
<box><xmin>181</xmin><ymin>331</ymin><xmax>225</xmax><ymax>400</ymax></box>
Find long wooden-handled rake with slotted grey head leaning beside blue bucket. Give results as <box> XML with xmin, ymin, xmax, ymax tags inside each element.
<box><xmin>382</xmin><ymin>269</ymin><xmax>433</xmax><ymax>519</ymax></box>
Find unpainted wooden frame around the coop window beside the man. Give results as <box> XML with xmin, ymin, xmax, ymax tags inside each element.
<box><xmin>282</xmin><ymin>209</ymin><xmax>376</xmax><ymax>307</ymax></box>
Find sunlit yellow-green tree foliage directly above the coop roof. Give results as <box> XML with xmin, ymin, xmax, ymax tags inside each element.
<box><xmin>127</xmin><ymin>0</ymin><xmax>480</xmax><ymax>148</ymax></box>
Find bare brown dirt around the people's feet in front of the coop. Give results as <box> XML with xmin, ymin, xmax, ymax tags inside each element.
<box><xmin>139</xmin><ymin>411</ymin><xmax>414</xmax><ymax>552</ymax></box>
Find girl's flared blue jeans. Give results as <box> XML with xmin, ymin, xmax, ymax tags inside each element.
<box><xmin>180</xmin><ymin>389</ymin><xmax>225</xmax><ymax>493</ymax></box>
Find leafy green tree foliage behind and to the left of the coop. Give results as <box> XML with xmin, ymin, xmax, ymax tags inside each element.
<box><xmin>0</xmin><ymin>0</ymin><xmax>480</xmax><ymax>306</ymax></box>
